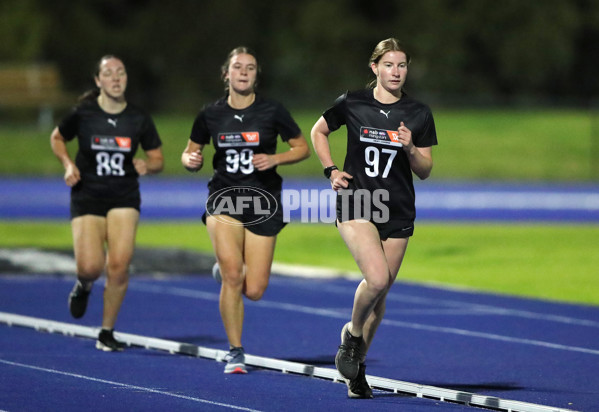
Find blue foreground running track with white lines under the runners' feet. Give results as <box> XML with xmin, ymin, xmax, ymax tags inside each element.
<box><xmin>0</xmin><ymin>275</ymin><xmax>599</xmax><ymax>411</ymax></box>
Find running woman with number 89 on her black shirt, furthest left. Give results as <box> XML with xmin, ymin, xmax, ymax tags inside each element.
<box><xmin>50</xmin><ymin>55</ymin><xmax>163</xmax><ymax>351</ymax></box>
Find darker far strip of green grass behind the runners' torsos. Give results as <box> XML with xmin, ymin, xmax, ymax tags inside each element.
<box><xmin>0</xmin><ymin>109</ymin><xmax>599</xmax><ymax>181</ymax></box>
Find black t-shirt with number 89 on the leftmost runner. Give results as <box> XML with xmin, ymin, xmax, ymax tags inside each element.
<box><xmin>58</xmin><ymin>100</ymin><xmax>162</xmax><ymax>198</ymax></box>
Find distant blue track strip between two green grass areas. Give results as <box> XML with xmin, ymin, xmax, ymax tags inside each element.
<box><xmin>0</xmin><ymin>176</ymin><xmax>599</xmax><ymax>223</ymax></box>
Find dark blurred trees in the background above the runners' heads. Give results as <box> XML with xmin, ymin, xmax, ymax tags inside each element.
<box><xmin>0</xmin><ymin>0</ymin><xmax>599</xmax><ymax>109</ymax></box>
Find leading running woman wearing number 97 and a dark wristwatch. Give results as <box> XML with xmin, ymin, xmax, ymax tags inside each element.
<box><xmin>311</xmin><ymin>38</ymin><xmax>437</xmax><ymax>398</ymax></box>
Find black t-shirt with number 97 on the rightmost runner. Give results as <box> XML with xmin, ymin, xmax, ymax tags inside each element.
<box><xmin>323</xmin><ymin>89</ymin><xmax>437</xmax><ymax>222</ymax></box>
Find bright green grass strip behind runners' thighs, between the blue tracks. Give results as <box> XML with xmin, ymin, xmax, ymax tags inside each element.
<box><xmin>0</xmin><ymin>221</ymin><xmax>599</xmax><ymax>305</ymax></box>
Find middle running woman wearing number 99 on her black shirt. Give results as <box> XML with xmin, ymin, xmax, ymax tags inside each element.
<box><xmin>181</xmin><ymin>47</ymin><xmax>310</xmax><ymax>373</ymax></box>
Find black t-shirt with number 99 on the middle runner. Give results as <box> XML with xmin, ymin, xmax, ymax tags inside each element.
<box><xmin>189</xmin><ymin>95</ymin><xmax>301</xmax><ymax>193</ymax></box>
